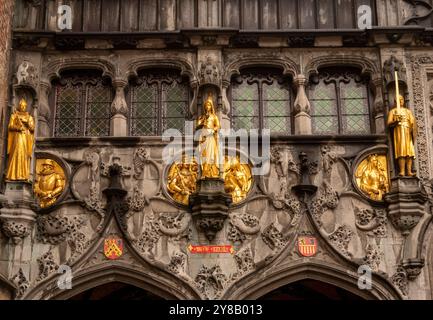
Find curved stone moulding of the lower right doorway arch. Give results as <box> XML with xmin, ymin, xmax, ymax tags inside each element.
<box><xmin>224</xmin><ymin>261</ymin><xmax>402</xmax><ymax>300</ymax></box>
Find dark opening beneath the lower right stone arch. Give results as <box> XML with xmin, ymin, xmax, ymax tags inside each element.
<box><xmin>259</xmin><ymin>279</ymin><xmax>364</xmax><ymax>301</ymax></box>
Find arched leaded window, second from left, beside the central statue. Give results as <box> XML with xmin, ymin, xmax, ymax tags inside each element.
<box><xmin>128</xmin><ymin>70</ymin><xmax>190</xmax><ymax>136</ymax></box>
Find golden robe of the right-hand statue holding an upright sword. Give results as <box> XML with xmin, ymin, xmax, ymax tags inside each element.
<box><xmin>388</xmin><ymin>107</ymin><xmax>416</xmax><ymax>159</ymax></box>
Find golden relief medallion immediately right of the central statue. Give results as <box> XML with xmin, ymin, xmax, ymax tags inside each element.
<box><xmin>223</xmin><ymin>156</ymin><xmax>252</xmax><ymax>203</ymax></box>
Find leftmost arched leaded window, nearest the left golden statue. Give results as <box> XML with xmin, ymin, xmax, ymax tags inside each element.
<box><xmin>54</xmin><ymin>70</ymin><xmax>113</xmax><ymax>137</ymax></box>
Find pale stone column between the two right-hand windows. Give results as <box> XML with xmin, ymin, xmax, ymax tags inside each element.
<box><xmin>294</xmin><ymin>74</ymin><xmax>312</xmax><ymax>134</ymax></box>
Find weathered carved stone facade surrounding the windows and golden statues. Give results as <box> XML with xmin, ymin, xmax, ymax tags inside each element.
<box><xmin>0</xmin><ymin>0</ymin><xmax>433</xmax><ymax>299</ymax></box>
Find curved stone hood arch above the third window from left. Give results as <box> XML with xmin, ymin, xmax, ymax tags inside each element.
<box><xmin>223</xmin><ymin>54</ymin><xmax>299</xmax><ymax>84</ymax></box>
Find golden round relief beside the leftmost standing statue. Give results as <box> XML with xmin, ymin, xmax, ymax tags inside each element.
<box><xmin>34</xmin><ymin>159</ymin><xmax>65</xmax><ymax>208</ymax></box>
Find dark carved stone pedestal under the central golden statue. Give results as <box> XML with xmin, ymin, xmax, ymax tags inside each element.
<box><xmin>189</xmin><ymin>178</ymin><xmax>232</xmax><ymax>241</ymax></box>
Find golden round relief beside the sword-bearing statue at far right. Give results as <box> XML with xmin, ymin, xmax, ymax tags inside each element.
<box><xmin>355</xmin><ymin>154</ymin><xmax>389</xmax><ymax>201</ymax></box>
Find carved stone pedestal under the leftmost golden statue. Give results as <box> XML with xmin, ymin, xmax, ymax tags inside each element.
<box><xmin>0</xmin><ymin>182</ymin><xmax>36</xmax><ymax>244</ymax></box>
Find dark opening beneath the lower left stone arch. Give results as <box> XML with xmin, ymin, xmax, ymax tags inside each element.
<box><xmin>69</xmin><ymin>281</ymin><xmax>164</xmax><ymax>300</ymax></box>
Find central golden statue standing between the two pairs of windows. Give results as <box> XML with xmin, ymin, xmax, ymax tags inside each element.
<box><xmin>196</xmin><ymin>94</ymin><xmax>221</xmax><ymax>178</ymax></box>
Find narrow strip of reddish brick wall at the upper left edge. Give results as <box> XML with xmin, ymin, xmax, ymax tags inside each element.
<box><xmin>0</xmin><ymin>0</ymin><xmax>14</xmax><ymax>175</ymax></box>
